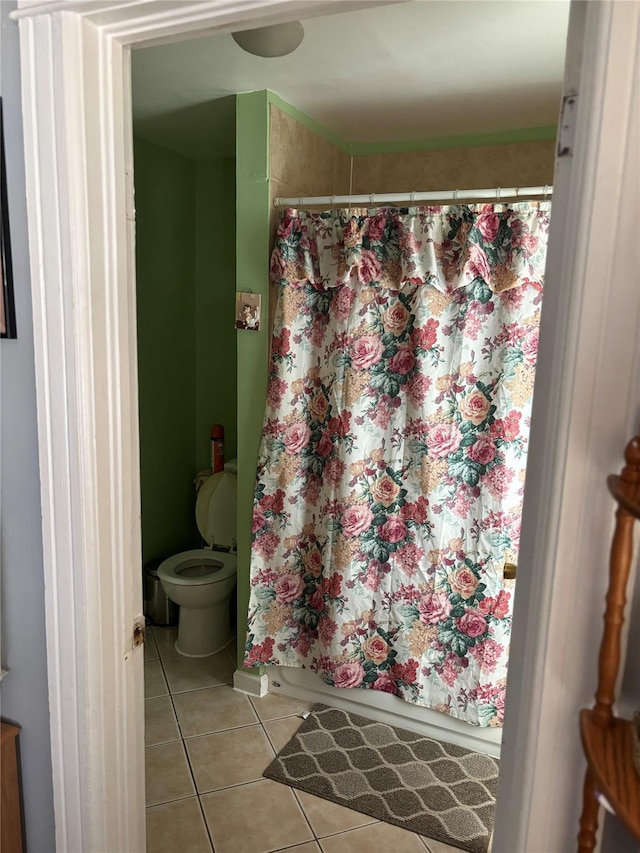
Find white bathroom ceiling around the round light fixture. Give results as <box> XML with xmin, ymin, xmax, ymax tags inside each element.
<box><xmin>133</xmin><ymin>0</ymin><xmax>569</xmax><ymax>159</ymax></box>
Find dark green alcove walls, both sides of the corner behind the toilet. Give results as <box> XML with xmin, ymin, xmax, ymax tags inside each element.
<box><xmin>134</xmin><ymin>139</ymin><xmax>237</xmax><ymax>562</ymax></box>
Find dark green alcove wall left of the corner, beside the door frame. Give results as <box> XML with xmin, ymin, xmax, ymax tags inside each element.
<box><xmin>134</xmin><ymin>140</ymin><xmax>196</xmax><ymax>562</ymax></box>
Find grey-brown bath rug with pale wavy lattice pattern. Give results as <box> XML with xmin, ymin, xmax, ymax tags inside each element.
<box><xmin>264</xmin><ymin>705</ymin><xmax>498</xmax><ymax>853</ymax></box>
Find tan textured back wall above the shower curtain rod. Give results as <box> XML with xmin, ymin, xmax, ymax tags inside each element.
<box><xmin>353</xmin><ymin>139</ymin><xmax>555</xmax><ymax>193</ymax></box>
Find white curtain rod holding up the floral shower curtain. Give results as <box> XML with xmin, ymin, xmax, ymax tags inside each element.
<box><xmin>273</xmin><ymin>186</ymin><xmax>553</xmax><ymax>207</ymax></box>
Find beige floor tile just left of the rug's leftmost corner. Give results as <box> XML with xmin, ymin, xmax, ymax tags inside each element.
<box><xmin>185</xmin><ymin>726</ymin><xmax>274</xmax><ymax>796</ymax></box>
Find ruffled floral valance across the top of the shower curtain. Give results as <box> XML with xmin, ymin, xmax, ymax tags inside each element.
<box><xmin>271</xmin><ymin>202</ymin><xmax>551</xmax><ymax>298</ymax></box>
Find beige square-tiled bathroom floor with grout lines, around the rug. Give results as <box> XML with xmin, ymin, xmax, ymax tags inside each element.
<box><xmin>145</xmin><ymin>628</ymin><xmax>464</xmax><ymax>853</ymax></box>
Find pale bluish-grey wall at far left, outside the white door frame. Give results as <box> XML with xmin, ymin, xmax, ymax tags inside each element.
<box><xmin>0</xmin><ymin>0</ymin><xmax>55</xmax><ymax>853</ymax></box>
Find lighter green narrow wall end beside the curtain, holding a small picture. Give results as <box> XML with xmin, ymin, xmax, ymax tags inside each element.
<box><xmin>236</xmin><ymin>91</ymin><xmax>269</xmax><ymax>667</ymax></box>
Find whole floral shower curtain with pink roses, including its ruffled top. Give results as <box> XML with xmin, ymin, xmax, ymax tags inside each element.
<box><xmin>245</xmin><ymin>203</ymin><xmax>550</xmax><ymax>726</ymax></box>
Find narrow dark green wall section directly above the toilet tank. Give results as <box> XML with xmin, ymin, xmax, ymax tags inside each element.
<box><xmin>194</xmin><ymin>157</ymin><xmax>238</xmax><ymax>471</ymax></box>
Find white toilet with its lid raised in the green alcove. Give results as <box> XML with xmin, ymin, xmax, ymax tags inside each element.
<box><xmin>158</xmin><ymin>463</ymin><xmax>237</xmax><ymax>658</ymax></box>
